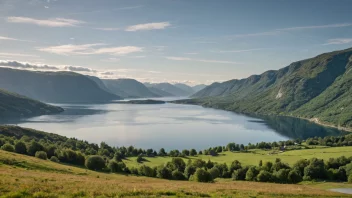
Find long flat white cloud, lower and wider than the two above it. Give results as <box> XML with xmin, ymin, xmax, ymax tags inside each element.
<box><xmin>38</xmin><ymin>43</ymin><xmax>143</xmax><ymax>55</ymax></box>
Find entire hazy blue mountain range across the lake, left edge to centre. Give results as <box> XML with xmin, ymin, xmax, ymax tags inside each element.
<box><xmin>0</xmin><ymin>67</ymin><xmax>206</xmax><ymax>103</ymax></box>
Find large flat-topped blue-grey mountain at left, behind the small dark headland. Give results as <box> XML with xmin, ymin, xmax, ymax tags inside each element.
<box><xmin>0</xmin><ymin>68</ymin><xmax>120</xmax><ymax>103</ymax></box>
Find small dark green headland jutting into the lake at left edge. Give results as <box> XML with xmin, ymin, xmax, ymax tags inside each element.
<box><xmin>0</xmin><ymin>89</ymin><xmax>63</xmax><ymax>118</ymax></box>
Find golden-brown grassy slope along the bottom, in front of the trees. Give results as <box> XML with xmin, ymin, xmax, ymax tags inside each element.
<box><xmin>0</xmin><ymin>151</ymin><xmax>352</xmax><ymax>197</ymax></box>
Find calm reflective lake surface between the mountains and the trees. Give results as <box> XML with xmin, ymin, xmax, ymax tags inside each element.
<box><xmin>2</xmin><ymin>100</ymin><xmax>341</xmax><ymax>150</ymax></box>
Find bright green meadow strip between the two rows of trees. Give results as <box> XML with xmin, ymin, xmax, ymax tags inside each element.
<box><xmin>124</xmin><ymin>146</ymin><xmax>352</xmax><ymax>167</ymax></box>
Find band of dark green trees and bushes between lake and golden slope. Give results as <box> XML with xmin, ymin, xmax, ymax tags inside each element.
<box><xmin>0</xmin><ymin>126</ymin><xmax>352</xmax><ymax>183</ymax></box>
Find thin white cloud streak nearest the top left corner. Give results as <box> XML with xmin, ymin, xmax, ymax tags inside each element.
<box><xmin>7</xmin><ymin>17</ymin><xmax>85</xmax><ymax>27</ymax></box>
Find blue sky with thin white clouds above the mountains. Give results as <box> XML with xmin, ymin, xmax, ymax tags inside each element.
<box><xmin>0</xmin><ymin>0</ymin><xmax>352</xmax><ymax>85</ymax></box>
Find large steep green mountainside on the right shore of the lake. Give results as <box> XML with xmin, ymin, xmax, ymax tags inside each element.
<box><xmin>192</xmin><ymin>48</ymin><xmax>352</xmax><ymax>129</ymax></box>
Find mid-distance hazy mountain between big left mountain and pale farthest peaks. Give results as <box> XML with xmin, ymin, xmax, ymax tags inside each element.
<box><xmin>102</xmin><ymin>79</ymin><xmax>160</xmax><ymax>98</ymax></box>
